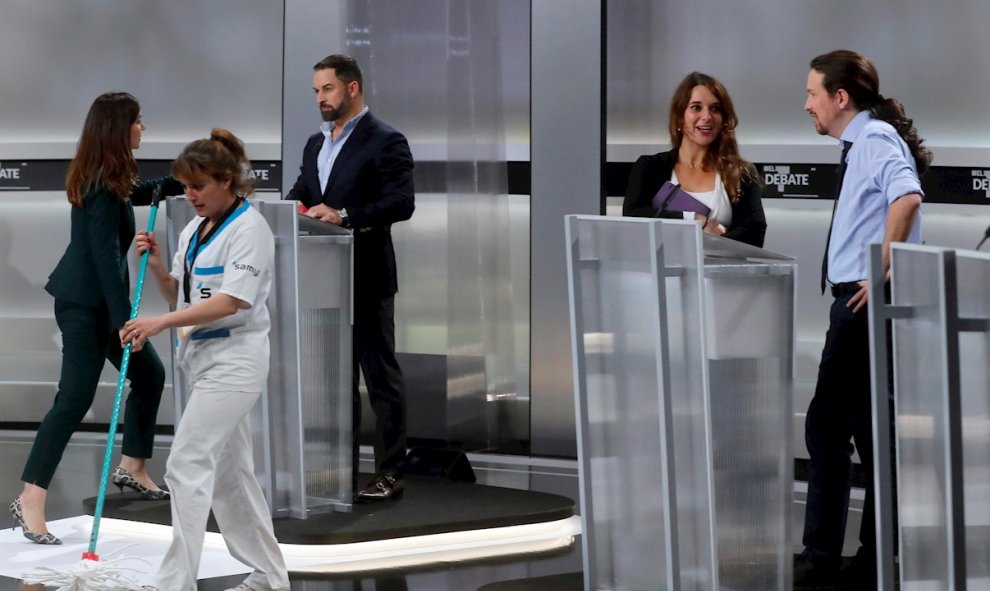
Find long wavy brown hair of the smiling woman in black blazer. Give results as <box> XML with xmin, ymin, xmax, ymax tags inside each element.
<box><xmin>667</xmin><ymin>72</ymin><xmax>759</xmax><ymax>203</ymax></box>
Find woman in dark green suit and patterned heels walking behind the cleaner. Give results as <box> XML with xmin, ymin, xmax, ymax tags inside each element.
<box><xmin>10</xmin><ymin>92</ymin><xmax>183</xmax><ymax>544</ymax></box>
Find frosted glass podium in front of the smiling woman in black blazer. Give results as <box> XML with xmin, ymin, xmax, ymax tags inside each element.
<box><xmin>566</xmin><ymin>216</ymin><xmax>796</xmax><ymax>591</ymax></box>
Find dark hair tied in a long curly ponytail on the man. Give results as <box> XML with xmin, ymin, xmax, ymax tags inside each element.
<box><xmin>810</xmin><ymin>49</ymin><xmax>932</xmax><ymax>175</ymax></box>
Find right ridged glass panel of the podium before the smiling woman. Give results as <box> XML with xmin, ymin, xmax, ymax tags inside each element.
<box><xmin>705</xmin><ymin>268</ymin><xmax>794</xmax><ymax>590</ymax></box>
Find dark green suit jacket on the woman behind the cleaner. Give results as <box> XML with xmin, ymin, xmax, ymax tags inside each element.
<box><xmin>45</xmin><ymin>177</ymin><xmax>183</xmax><ymax>329</ymax></box>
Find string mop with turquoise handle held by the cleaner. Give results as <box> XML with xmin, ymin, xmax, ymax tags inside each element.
<box><xmin>23</xmin><ymin>185</ymin><xmax>162</xmax><ymax>591</ymax></box>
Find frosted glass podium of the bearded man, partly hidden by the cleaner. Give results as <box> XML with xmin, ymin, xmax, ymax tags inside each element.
<box><xmin>167</xmin><ymin>197</ymin><xmax>354</xmax><ymax>519</ymax></box>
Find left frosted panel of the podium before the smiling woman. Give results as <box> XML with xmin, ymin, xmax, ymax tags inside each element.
<box><xmin>568</xmin><ymin>218</ymin><xmax>667</xmax><ymax>591</ymax></box>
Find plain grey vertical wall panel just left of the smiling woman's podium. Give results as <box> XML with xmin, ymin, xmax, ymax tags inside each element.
<box><xmin>530</xmin><ymin>0</ymin><xmax>604</xmax><ymax>457</ymax></box>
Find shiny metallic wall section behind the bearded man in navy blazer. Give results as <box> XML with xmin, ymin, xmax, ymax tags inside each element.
<box><xmin>283</xmin><ymin>0</ymin><xmax>529</xmax><ymax>449</ymax></box>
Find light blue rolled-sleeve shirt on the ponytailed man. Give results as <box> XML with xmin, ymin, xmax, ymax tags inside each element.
<box><xmin>828</xmin><ymin>111</ymin><xmax>924</xmax><ymax>284</ymax></box>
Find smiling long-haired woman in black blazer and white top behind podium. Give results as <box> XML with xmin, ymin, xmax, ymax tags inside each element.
<box><xmin>622</xmin><ymin>72</ymin><xmax>767</xmax><ymax>247</ymax></box>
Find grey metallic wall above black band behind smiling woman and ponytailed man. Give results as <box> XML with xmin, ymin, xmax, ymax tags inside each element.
<box><xmin>608</xmin><ymin>0</ymin><xmax>990</xmax><ymax>156</ymax></box>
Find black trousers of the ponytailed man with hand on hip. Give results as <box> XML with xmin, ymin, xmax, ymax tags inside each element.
<box><xmin>803</xmin><ymin>294</ymin><xmax>876</xmax><ymax>566</ymax></box>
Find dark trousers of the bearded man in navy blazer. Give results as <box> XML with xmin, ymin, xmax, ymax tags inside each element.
<box><xmin>352</xmin><ymin>296</ymin><xmax>406</xmax><ymax>478</ymax></box>
